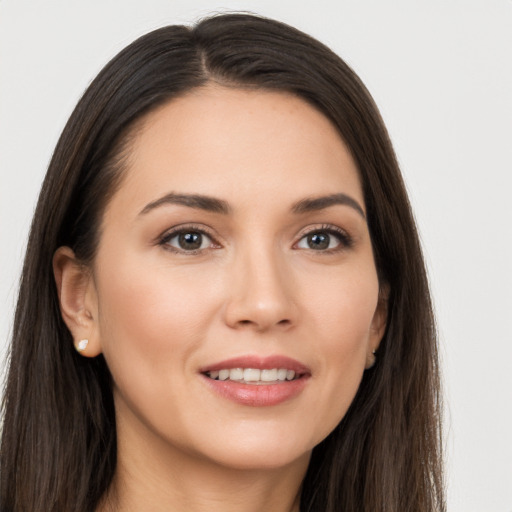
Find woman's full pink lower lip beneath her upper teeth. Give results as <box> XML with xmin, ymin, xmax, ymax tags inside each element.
<box><xmin>202</xmin><ymin>375</ymin><xmax>309</xmax><ymax>407</ymax></box>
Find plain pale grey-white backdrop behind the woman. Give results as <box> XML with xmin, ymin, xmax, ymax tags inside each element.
<box><xmin>0</xmin><ymin>0</ymin><xmax>512</xmax><ymax>512</ymax></box>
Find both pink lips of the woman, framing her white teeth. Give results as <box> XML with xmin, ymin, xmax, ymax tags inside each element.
<box><xmin>201</xmin><ymin>356</ymin><xmax>311</xmax><ymax>407</ymax></box>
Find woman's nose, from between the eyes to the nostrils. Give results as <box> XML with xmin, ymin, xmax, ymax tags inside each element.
<box><xmin>224</xmin><ymin>244</ymin><xmax>298</xmax><ymax>332</ymax></box>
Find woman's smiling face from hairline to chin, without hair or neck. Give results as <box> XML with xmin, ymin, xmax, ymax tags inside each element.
<box><xmin>91</xmin><ymin>86</ymin><xmax>385</xmax><ymax>468</ymax></box>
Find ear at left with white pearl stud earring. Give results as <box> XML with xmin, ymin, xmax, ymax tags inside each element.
<box><xmin>53</xmin><ymin>247</ymin><xmax>101</xmax><ymax>357</ymax></box>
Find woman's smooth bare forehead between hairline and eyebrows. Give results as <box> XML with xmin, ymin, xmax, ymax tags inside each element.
<box><xmin>108</xmin><ymin>85</ymin><xmax>363</xmax><ymax>216</ymax></box>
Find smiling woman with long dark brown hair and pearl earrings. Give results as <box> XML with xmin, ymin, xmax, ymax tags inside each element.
<box><xmin>1</xmin><ymin>15</ymin><xmax>444</xmax><ymax>511</ymax></box>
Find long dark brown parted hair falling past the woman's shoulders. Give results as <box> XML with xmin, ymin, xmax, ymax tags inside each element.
<box><xmin>0</xmin><ymin>14</ymin><xmax>445</xmax><ymax>512</ymax></box>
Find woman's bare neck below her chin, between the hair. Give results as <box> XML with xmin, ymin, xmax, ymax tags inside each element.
<box><xmin>97</xmin><ymin>410</ymin><xmax>310</xmax><ymax>512</ymax></box>
